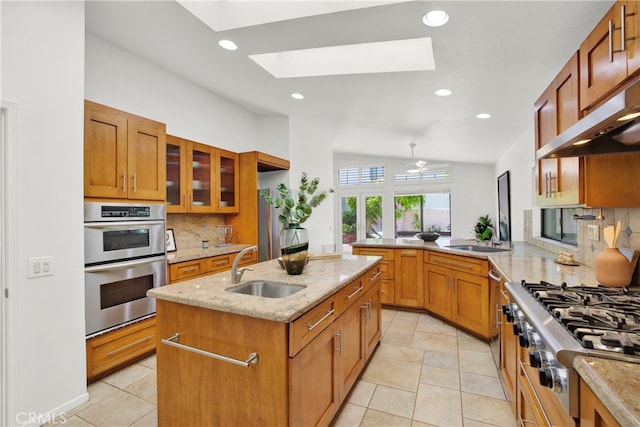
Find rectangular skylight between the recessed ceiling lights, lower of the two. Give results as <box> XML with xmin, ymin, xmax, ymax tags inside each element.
<box><xmin>249</xmin><ymin>37</ymin><xmax>435</xmax><ymax>79</ymax></box>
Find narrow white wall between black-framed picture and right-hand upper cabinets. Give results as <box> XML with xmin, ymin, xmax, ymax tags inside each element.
<box><xmin>495</xmin><ymin>122</ymin><xmax>539</xmax><ymax>241</ymax></box>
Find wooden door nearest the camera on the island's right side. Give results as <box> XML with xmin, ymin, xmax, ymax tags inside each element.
<box><xmin>289</xmin><ymin>327</ymin><xmax>340</xmax><ymax>426</ymax></box>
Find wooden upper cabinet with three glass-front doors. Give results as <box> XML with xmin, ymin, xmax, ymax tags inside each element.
<box><xmin>166</xmin><ymin>135</ymin><xmax>239</xmax><ymax>213</ymax></box>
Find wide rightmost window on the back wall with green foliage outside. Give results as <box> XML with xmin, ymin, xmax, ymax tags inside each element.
<box><xmin>394</xmin><ymin>193</ymin><xmax>451</xmax><ymax>237</ymax></box>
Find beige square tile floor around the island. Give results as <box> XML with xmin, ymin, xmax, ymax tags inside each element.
<box><xmin>52</xmin><ymin>309</ymin><xmax>516</xmax><ymax>427</ymax></box>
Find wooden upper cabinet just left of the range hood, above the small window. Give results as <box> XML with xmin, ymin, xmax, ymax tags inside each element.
<box><xmin>534</xmin><ymin>53</ymin><xmax>584</xmax><ymax>206</ymax></box>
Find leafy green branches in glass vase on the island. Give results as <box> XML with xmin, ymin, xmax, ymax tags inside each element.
<box><xmin>260</xmin><ymin>172</ymin><xmax>333</xmax><ymax>274</ymax></box>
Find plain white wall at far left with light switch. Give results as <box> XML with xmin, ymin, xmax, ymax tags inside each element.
<box><xmin>1</xmin><ymin>1</ymin><xmax>88</xmax><ymax>425</ymax></box>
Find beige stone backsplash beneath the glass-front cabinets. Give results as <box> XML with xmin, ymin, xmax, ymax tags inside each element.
<box><xmin>167</xmin><ymin>214</ymin><xmax>225</xmax><ymax>249</ymax></box>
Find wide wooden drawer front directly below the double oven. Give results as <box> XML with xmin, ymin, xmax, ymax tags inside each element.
<box><xmin>86</xmin><ymin>317</ymin><xmax>156</xmax><ymax>381</ymax></box>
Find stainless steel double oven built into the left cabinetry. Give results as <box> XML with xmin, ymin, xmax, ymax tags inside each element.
<box><xmin>84</xmin><ymin>202</ymin><xmax>167</xmax><ymax>337</ymax></box>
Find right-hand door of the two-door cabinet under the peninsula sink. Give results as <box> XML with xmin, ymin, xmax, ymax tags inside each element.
<box><xmin>452</xmin><ymin>272</ymin><xmax>489</xmax><ymax>337</ymax></box>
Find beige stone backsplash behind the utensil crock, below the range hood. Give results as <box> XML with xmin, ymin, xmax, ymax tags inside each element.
<box><xmin>523</xmin><ymin>208</ymin><xmax>640</xmax><ymax>283</ymax></box>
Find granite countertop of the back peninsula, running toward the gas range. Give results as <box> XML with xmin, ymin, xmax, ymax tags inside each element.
<box><xmin>353</xmin><ymin>236</ymin><xmax>598</xmax><ymax>286</ymax></box>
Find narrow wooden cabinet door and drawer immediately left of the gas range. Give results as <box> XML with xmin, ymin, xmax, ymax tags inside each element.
<box><xmin>500</xmin><ymin>289</ymin><xmax>518</xmax><ymax>412</ymax></box>
